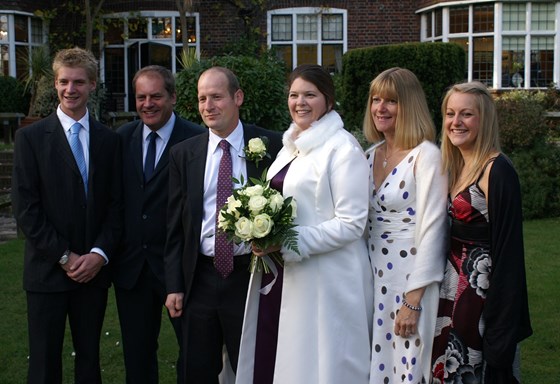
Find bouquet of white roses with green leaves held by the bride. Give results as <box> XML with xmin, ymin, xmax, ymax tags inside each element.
<box><xmin>218</xmin><ymin>170</ymin><xmax>299</xmax><ymax>273</ymax></box>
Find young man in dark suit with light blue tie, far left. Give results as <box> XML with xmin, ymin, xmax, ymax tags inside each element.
<box><xmin>12</xmin><ymin>48</ymin><xmax>122</xmax><ymax>384</ymax></box>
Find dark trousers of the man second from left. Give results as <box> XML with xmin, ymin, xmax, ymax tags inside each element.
<box><xmin>115</xmin><ymin>262</ymin><xmax>184</xmax><ymax>384</ymax></box>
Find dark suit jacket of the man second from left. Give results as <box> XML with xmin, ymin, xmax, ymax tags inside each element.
<box><xmin>112</xmin><ymin>116</ymin><xmax>206</xmax><ymax>289</ymax></box>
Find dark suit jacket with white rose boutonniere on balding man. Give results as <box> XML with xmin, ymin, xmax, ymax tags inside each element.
<box><xmin>165</xmin><ymin>124</ymin><xmax>282</xmax><ymax>301</ymax></box>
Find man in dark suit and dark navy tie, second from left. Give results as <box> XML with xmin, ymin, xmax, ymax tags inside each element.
<box><xmin>112</xmin><ymin>65</ymin><xmax>205</xmax><ymax>384</ymax></box>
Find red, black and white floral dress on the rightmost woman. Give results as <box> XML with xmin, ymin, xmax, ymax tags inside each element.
<box><xmin>432</xmin><ymin>176</ymin><xmax>492</xmax><ymax>384</ymax></box>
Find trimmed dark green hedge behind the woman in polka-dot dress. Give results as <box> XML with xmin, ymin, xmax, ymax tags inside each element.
<box><xmin>339</xmin><ymin>43</ymin><xmax>466</xmax><ymax>131</ymax></box>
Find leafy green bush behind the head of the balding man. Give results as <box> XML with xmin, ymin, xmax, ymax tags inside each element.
<box><xmin>175</xmin><ymin>55</ymin><xmax>290</xmax><ymax>131</ymax></box>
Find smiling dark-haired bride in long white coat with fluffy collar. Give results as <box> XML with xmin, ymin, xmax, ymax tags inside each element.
<box><xmin>236</xmin><ymin>65</ymin><xmax>373</xmax><ymax>384</ymax></box>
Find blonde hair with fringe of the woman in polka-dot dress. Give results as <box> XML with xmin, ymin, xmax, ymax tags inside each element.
<box><xmin>364</xmin><ymin>67</ymin><xmax>436</xmax><ymax>149</ymax></box>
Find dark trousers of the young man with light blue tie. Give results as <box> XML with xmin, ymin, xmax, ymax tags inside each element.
<box><xmin>27</xmin><ymin>284</ymin><xmax>108</xmax><ymax>384</ymax></box>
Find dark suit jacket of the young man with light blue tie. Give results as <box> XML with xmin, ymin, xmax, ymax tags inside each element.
<box><xmin>12</xmin><ymin>113</ymin><xmax>122</xmax><ymax>292</ymax></box>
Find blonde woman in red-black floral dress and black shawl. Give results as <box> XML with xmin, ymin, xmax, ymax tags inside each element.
<box><xmin>433</xmin><ymin>82</ymin><xmax>532</xmax><ymax>384</ymax></box>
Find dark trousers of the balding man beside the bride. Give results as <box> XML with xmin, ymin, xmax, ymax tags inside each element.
<box><xmin>182</xmin><ymin>255</ymin><xmax>250</xmax><ymax>384</ymax></box>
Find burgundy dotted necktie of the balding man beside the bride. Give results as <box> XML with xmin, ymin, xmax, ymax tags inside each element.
<box><xmin>214</xmin><ymin>140</ymin><xmax>233</xmax><ymax>279</ymax></box>
